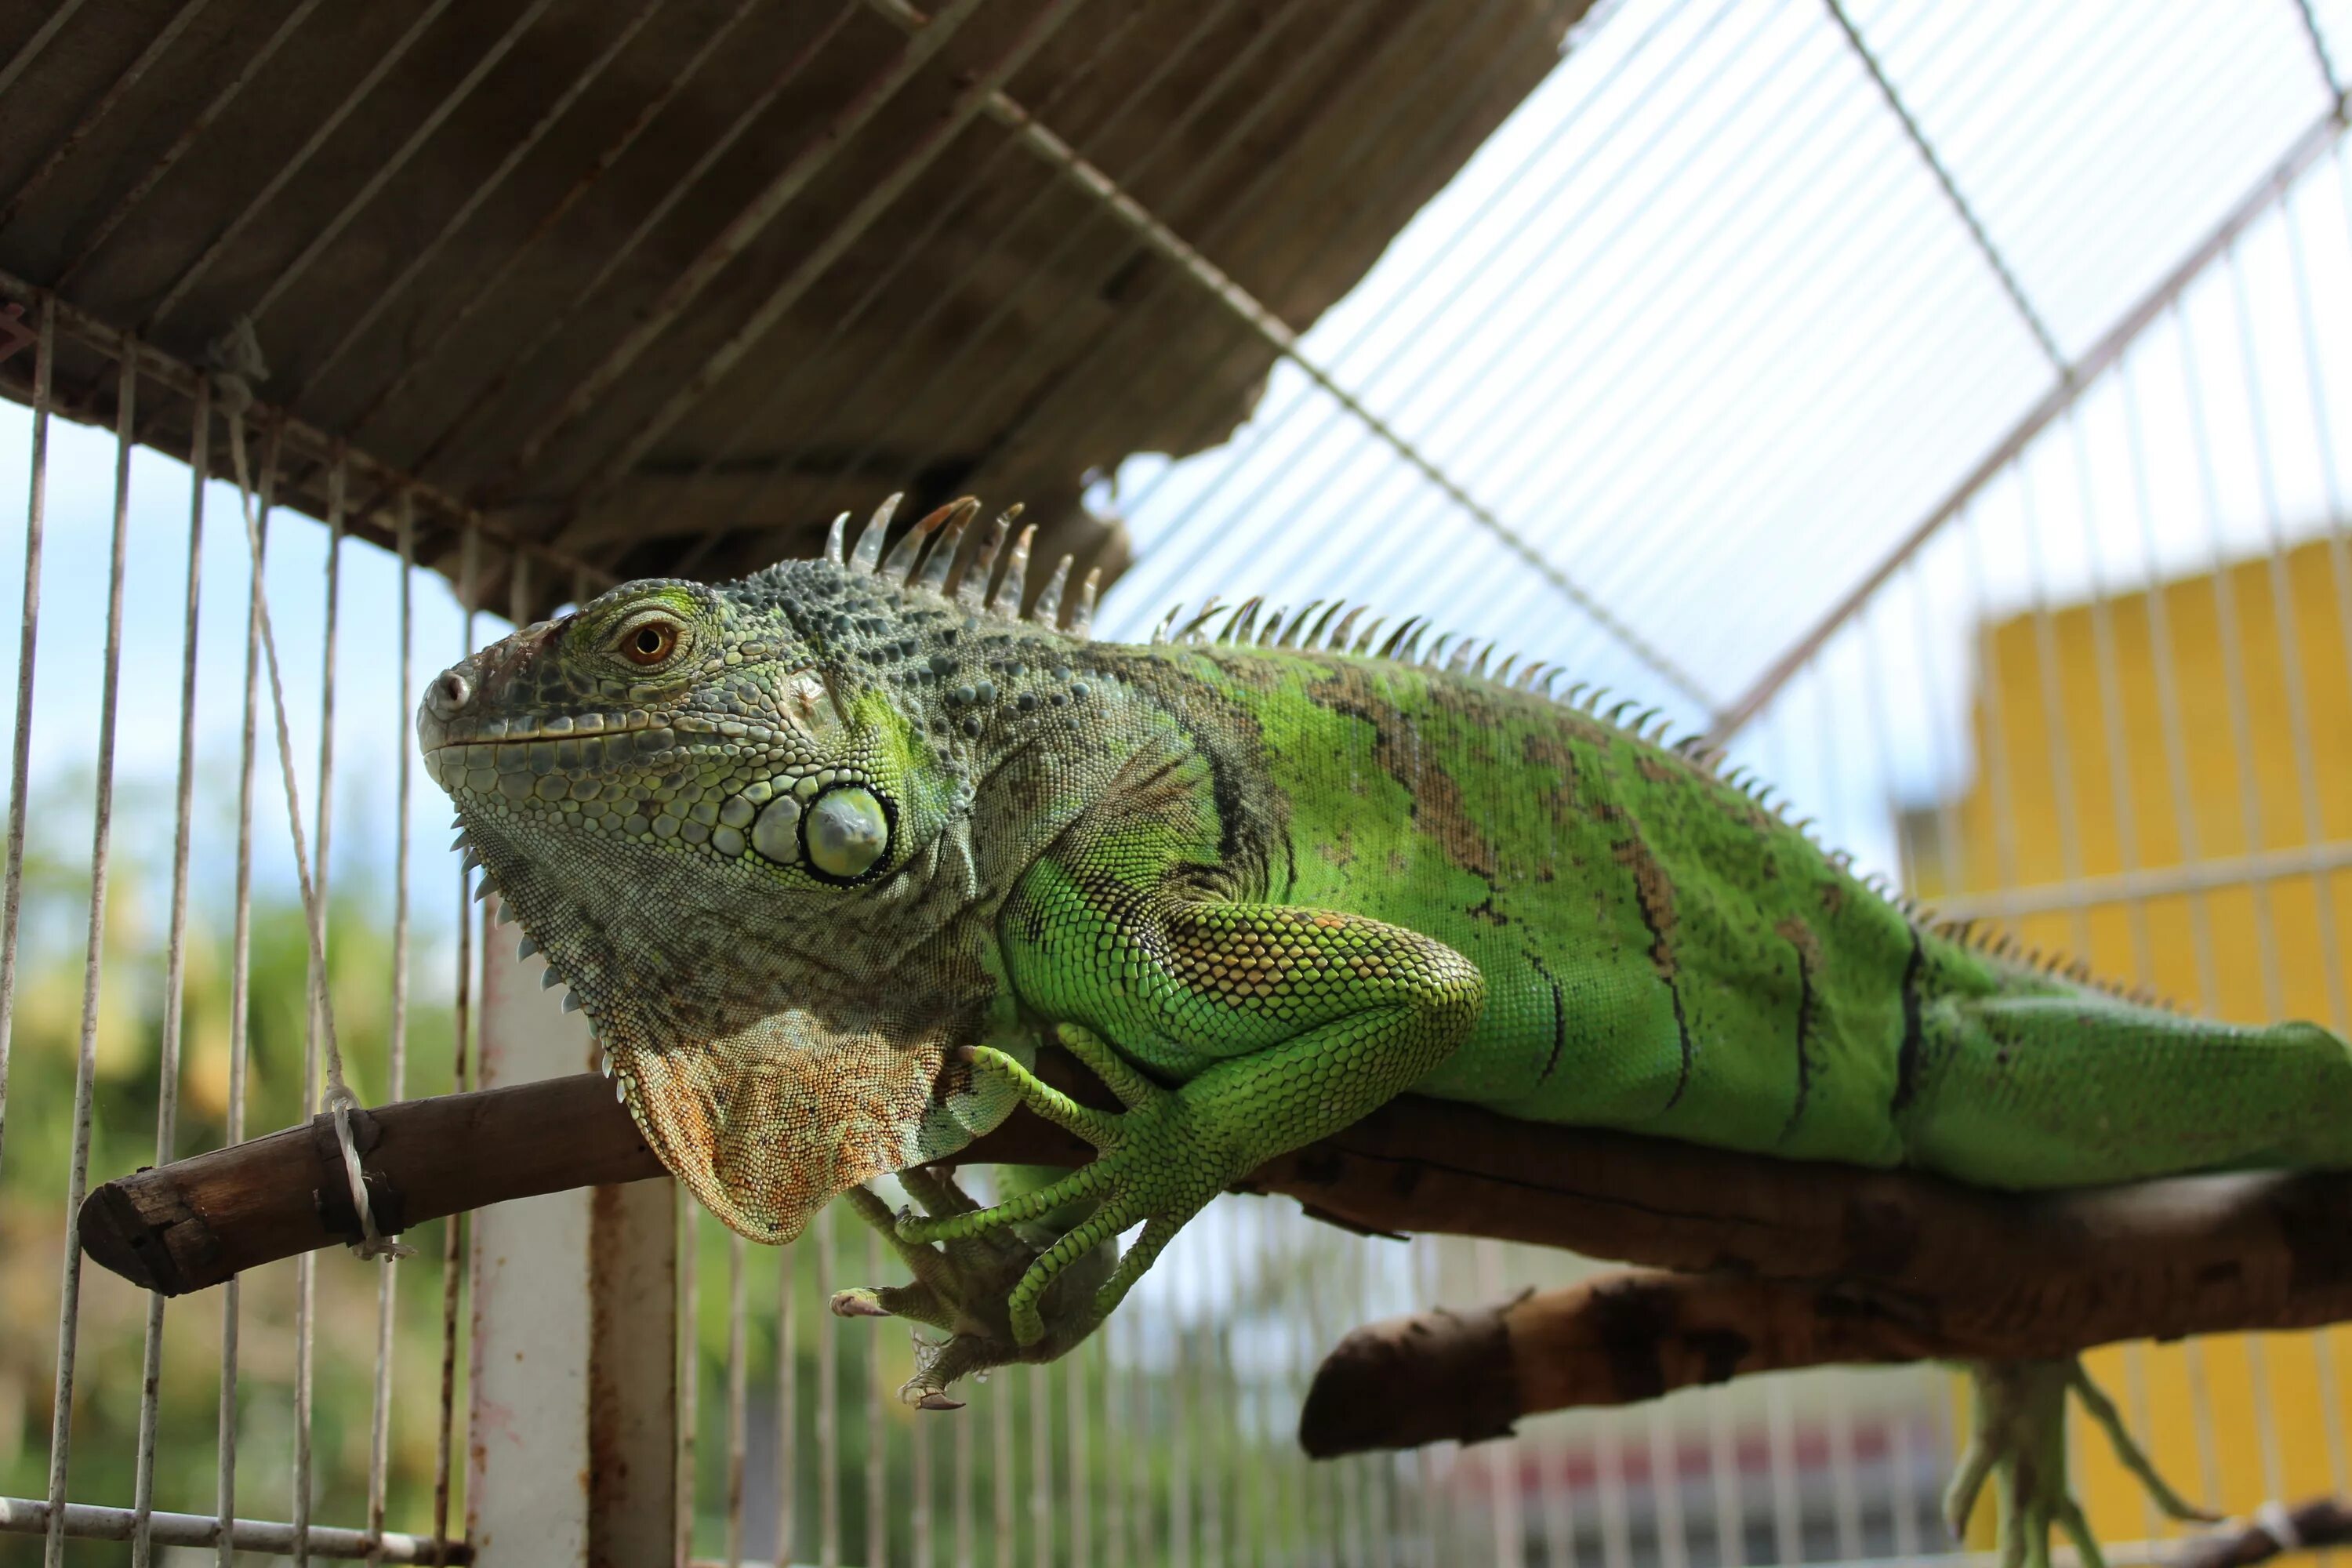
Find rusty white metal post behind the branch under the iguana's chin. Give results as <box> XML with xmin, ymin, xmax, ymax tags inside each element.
<box><xmin>466</xmin><ymin>902</ymin><xmax>677</xmax><ymax>1568</ymax></box>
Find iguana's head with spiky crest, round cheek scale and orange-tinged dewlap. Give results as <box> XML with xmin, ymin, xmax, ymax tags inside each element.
<box><xmin>416</xmin><ymin>503</ymin><xmax>1091</xmax><ymax>1241</ymax></box>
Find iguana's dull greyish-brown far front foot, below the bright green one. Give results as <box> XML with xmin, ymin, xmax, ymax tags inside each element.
<box><xmin>830</xmin><ymin>1166</ymin><xmax>1110</xmax><ymax>1410</ymax></box>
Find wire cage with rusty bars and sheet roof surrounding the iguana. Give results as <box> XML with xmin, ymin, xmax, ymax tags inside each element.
<box><xmin>0</xmin><ymin>0</ymin><xmax>2352</xmax><ymax>1568</ymax></box>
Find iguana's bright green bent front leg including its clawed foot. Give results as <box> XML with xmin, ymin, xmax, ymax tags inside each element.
<box><xmin>898</xmin><ymin>902</ymin><xmax>1484</xmax><ymax>1345</ymax></box>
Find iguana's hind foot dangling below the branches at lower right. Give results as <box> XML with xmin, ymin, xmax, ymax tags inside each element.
<box><xmin>1943</xmin><ymin>1356</ymin><xmax>2216</xmax><ymax>1568</ymax></box>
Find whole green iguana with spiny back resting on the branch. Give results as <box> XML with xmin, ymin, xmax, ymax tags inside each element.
<box><xmin>419</xmin><ymin>501</ymin><xmax>2352</xmax><ymax>1561</ymax></box>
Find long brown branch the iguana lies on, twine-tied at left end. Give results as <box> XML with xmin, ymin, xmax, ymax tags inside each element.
<box><xmin>80</xmin><ymin>1051</ymin><xmax>2352</xmax><ymax>1401</ymax></box>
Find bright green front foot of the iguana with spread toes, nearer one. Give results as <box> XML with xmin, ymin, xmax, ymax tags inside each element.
<box><xmin>898</xmin><ymin>1025</ymin><xmax>1249</xmax><ymax>1347</ymax></box>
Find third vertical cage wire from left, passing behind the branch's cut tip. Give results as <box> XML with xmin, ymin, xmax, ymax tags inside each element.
<box><xmin>132</xmin><ymin>381</ymin><xmax>212</xmax><ymax>1568</ymax></box>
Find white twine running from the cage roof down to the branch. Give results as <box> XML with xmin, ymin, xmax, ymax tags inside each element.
<box><xmin>207</xmin><ymin>318</ymin><xmax>416</xmax><ymax>1258</ymax></box>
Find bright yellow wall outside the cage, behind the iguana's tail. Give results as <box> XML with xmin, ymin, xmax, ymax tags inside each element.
<box><xmin>1905</xmin><ymin>543</ymin><xmax>2352</xmax><ymax>1544</ymax></box>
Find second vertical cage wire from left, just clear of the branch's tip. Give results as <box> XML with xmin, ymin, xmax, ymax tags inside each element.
<box><xmin>42</xmin><ymin>336</ymin><xmax>139</xmax><ymax>1568</ymax></box>
